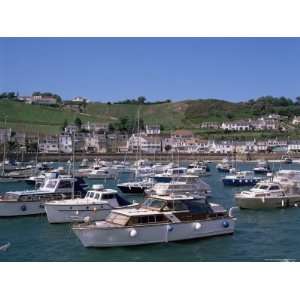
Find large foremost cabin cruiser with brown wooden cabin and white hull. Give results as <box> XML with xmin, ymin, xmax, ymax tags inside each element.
<box><xmin>72</xmin><ymin>195</ymin><xmax>235</xmax><ymax>247</ymax></box>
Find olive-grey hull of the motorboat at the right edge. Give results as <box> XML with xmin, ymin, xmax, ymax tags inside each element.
<box><xmin>235</xmin><ymin>196</ymin><xmax>300</xmax><ymax>209</ymax></box>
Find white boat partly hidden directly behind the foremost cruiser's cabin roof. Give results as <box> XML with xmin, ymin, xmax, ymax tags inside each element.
<box><xmin>146</xmin><ymin>175</ymin><xmax>211</xmax><ymax>197</ymax></box>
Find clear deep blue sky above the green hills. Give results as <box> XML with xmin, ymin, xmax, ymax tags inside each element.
<box><xmin>0</xmin><ymin>38</ymin><xmax>300</xmax><ymax>101</ymax></box>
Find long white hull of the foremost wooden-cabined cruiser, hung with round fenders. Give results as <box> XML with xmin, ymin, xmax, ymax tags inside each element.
<box><xmin>73</xmin><ymin>217</ymin><xmax>234</xmax><ymax>247</ymax></box>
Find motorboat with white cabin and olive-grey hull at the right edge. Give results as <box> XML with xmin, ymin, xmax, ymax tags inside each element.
<box><xmin>235</xmin><ymin>181</ymin><xmax>300</xmax><ymax>209</ymax></box>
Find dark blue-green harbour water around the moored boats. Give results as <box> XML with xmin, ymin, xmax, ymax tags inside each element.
<box><xmin>0</xmin><ymin>163</ymin><xmax>300</xmax><ymax>261</ymax></box>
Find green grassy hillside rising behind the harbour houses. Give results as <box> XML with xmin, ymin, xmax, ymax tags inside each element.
<box><xmin>0</xmin><ymin>96</ymin><xmax>300</xmax><ymax>134</ymax></box>
